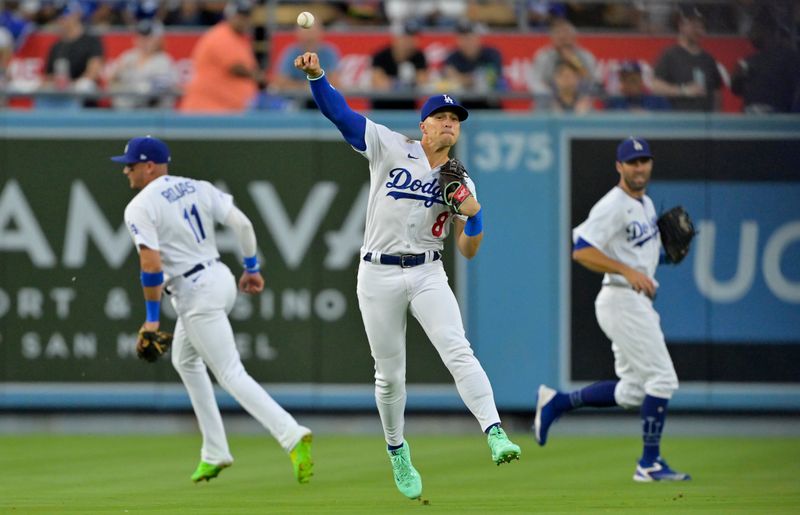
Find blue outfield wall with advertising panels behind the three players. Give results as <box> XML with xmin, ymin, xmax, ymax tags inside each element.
<box><xmin>0</xmin><ymin>112</ymin><xmax>800</xmax><ymax>410</ymax></box>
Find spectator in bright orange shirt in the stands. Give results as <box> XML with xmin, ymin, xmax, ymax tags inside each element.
<box><xmin>180</xmin><ymin>0</ymin><xmax>266</xmax><ymax>113</ymax></box>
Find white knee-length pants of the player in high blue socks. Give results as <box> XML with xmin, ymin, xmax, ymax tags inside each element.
<box><xmin>595</xmin><ymin>286</ymin><xmax>678</xmax><ymax>408</ymax></box>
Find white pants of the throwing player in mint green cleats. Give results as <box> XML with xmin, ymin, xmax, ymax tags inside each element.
<box><xmin>357</xmin><ymin>261</ymin><xmax>500</xmax><ymax>445</ymax></box>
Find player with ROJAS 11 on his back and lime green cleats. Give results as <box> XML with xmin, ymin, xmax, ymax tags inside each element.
<box><xmin>111</xmin><ymin>136</ymin><xmax>313</xmax><ymax>483</ymax></box>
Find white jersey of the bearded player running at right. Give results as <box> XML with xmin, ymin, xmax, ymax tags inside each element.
<box><xmin>572</xmin><ymin>186</ymin><xmax>661</xmax><ymax>285</ymax></box>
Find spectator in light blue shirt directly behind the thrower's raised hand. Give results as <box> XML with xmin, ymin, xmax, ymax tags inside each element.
<box><xmin>270</xmin><ymin>22</ymin><xmax>340</xmax><ymax>103</ymax></box>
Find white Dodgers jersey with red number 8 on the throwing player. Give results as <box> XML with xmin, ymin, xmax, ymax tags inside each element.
<box><xmin>359</xmin><ymin>119</ymin><xmax>477</xmax><ymax>254</ymax></box>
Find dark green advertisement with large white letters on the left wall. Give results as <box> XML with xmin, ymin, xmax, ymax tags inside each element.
<box><xmin>0</xmin><ymin>121</ymin><xmax>460</xmax><ymax>408</ymax></box>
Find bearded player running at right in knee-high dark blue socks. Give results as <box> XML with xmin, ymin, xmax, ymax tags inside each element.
<box><xmin>534</xmin><ymin>138</ymin><xmax>690</xmax><ymax>482</ymax></box>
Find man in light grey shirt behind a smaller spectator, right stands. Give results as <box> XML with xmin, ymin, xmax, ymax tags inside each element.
<box><xmin>529</xmin><ymin>18</ymin><xmax>597</xmax><ymax>96</ymax></box>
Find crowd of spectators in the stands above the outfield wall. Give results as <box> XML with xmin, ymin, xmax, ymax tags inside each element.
<box><xmin>0</xmin><ymin>0</ymin><xmax>800</xmax><ymax>114</ymax></box>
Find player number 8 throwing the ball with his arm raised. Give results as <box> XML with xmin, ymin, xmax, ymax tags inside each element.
<box><xmin>295</xmin><ymin>52</ymin><xmax>520</xmax><ymax>499</ymax></box>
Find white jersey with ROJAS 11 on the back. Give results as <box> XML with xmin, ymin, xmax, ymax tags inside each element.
<box><xmin>125</xmin><ymin>175</ymin><xmax>233</xmax><ymax>277</ymax></box>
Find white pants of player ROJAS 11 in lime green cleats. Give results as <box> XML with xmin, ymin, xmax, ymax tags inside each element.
<box><xmin>169</xmin><ymin>262</ymin><xmax>310</xmax><ymax>465</ymax></box>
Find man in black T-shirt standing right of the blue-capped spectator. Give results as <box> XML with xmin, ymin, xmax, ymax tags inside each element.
<box><xmin>653</xmin><ymin>9</ymin><xmax>722</xmax><ymax>111</ymax></box>
